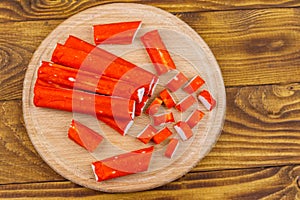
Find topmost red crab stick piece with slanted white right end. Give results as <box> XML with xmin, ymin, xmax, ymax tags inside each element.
<box><xmin>93</xmin><ymin>21</ymin><xmax>142</xmax><ymax>45</ymax></box>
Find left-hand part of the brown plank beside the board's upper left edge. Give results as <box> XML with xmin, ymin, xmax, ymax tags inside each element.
<box><xmin>0</xmin><ymin>21</ymin><xmax>60</xmax><ymax>100</ymax></box>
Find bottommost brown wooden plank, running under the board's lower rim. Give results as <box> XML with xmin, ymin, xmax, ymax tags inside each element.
<box><xmin>0</xmin><ymin>166</ymin><xmax>300</xmax><ymax>200</ymax></box>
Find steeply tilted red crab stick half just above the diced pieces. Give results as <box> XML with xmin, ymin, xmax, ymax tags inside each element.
<box><xmin>141</xmin><ymin>30</ymin><xmax>176</xmax><ymax>76</ymax></box>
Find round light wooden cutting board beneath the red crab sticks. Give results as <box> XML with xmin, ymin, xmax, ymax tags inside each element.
<box><xmin>23</xmin><ymin>3</ymin><xmax>226</xmax><ymax>192</ymax></box>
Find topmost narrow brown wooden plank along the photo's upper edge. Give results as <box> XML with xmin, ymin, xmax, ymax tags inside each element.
<box><xmin>0</xmin><ymin>0</ymin><xmax>300</xmax><ymax>22</ymax></box>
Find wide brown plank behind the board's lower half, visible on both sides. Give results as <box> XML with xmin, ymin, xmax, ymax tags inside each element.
<box><xmin>0</xmin><ymin>84</ymin><xmax>300</xmax><ymax>184</ymax></box>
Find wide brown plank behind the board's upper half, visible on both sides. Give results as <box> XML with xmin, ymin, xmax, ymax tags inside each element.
<box><xmin>0</xmin><ymin>8</ymin><xmax>300</xmax><ymax>100</ymax></box>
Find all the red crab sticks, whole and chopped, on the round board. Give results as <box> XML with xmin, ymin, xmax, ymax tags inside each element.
<box><xmin>33</xmin><ymin>21</ymin><xmax>216</xmax><ymax>181</ymax></box>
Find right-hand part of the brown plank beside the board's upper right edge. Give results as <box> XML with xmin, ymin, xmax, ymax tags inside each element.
<box><xmin>180</xmin><ymin>9</ymin><xmax>300</xmax><ymax>86</ymax></box>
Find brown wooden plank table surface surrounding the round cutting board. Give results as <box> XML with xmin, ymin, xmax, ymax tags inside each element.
<box><xmin>0</xmin><ymin>0</ymin><xmax>300</xmax><ymax>199</ymax></box>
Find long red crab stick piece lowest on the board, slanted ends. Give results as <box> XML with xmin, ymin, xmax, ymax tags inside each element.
<box><xmin>92</xmin><ymin>146</ymin><xmax>154</xmax><ymax>182</ymax></box>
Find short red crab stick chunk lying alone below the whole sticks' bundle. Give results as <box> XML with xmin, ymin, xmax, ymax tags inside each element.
<box><xmin>68</xmin><ymin>120</ymin><xmax>103</xmax><ymax>152</ymax></box>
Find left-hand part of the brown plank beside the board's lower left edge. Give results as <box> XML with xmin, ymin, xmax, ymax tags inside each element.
<box><xmin>0</xmin><ymin>101</ymin><xmax>62</xmax><ymax>184</ymax></box>
